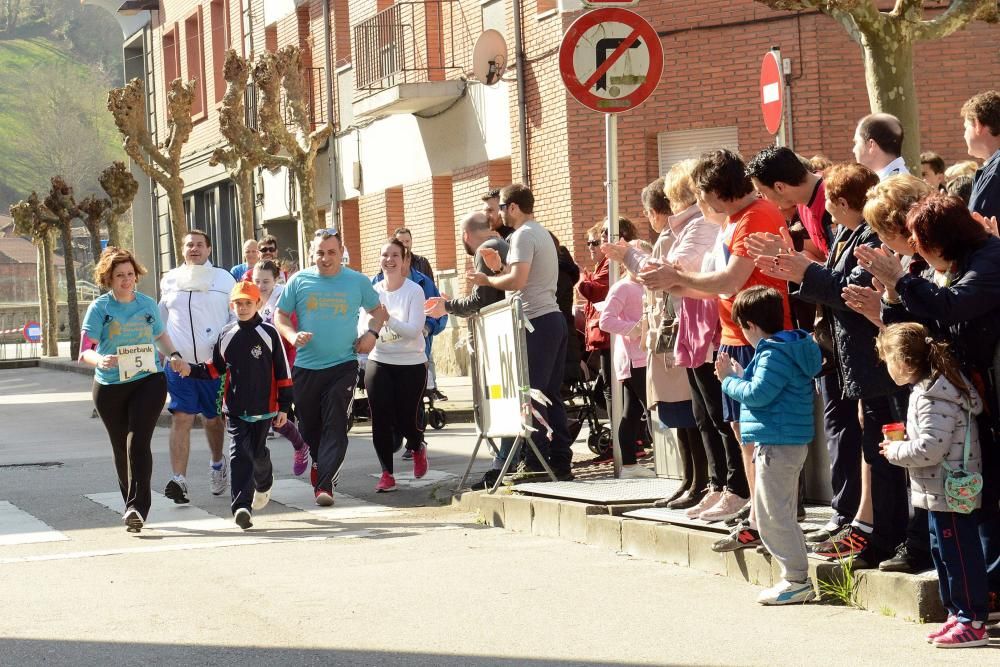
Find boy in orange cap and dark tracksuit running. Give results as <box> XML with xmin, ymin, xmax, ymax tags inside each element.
<box><xmin>175</xmin><ymin>281</ymin><xmax>292</xmax><ymax>530</ymax></box>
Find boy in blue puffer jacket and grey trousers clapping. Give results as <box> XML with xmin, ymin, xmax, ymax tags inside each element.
<box><xmin>715</xmin><ymin>286</ymin><xmax>823</xmax><ymax>604</ymax></box>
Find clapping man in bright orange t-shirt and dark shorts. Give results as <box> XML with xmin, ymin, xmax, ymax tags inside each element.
<box><xmin>639</xmin><ymin>150</ymin><xmax>792</xmax><ymax>540</ymax></box>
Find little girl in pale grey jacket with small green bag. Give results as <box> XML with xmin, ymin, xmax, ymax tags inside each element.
<box><xmin>876</xmin><ymin>322</ymin><xmax>989</xmax><ymax>648</ymax></box>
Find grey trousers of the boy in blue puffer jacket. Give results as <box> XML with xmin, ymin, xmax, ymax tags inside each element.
<box><xmin>753</xmin><ymin>445</ymin><xmax>809</xmax><ymax>583</ymax></box>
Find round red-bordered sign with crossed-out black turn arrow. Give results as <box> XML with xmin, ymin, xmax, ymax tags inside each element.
<box><xmin>559</xmin><ymin>7</ymin><xmax>663</xmax><ymax>113</ymax></box>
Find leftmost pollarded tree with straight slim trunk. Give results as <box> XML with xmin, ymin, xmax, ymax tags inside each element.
<box><xmin>10</xmin><ymin>192</ymin><xmax>59</xmax><ymax>357</ymax></box>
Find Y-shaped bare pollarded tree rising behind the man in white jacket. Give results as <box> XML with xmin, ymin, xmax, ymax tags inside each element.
<box><xmin>108</xmin><ymin>79</ymin><xmax>194</xmax><ymax>258</ymax></box>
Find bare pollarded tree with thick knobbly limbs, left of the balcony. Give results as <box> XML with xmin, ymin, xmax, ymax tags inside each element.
<box><xmin>214</xmin><ymin>46</ymin><xmax>333</xmax><ymax>238</ymax></box>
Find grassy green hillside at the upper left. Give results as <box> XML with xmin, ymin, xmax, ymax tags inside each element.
<box><xmin>0</xmin><ymin>37</ymin><xmax>121</xmax><ymax>212</ymax></box>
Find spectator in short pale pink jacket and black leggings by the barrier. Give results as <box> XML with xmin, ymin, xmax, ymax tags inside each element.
<box><xmin>599</xmin><ymin>241</ymin><xmax>656</xmax><ymax>479</ymax></box>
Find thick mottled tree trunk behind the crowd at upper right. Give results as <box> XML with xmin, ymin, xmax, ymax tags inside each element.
<box><xmin>861</xmin><ymin>21</ymin><xmax>920</xmax><ymax>174</ymax></box>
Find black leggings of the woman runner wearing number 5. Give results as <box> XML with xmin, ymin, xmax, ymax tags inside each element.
<box><xmin>93</xmin><ymin>373</ymin><xmax>167</xmax><ymax>520</ymax></box>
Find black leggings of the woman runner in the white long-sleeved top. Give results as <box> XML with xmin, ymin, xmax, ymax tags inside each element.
<box><xmin>365</xmin><ymin>359</ymin><xmax>427</xmax><ymax>475</ymax></box>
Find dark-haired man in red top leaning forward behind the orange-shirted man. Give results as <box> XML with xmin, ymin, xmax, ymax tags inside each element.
<box><xmin>747</xmin><ymin>146</ymin><xmax>833</xmax><ymax>262</ymax></box>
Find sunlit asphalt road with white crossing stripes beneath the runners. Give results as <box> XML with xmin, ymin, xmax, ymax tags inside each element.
<box><xmin>0</xmin><ymin>369</ymin><xmax>1000</xmax><ymax>667</ymax></box>
